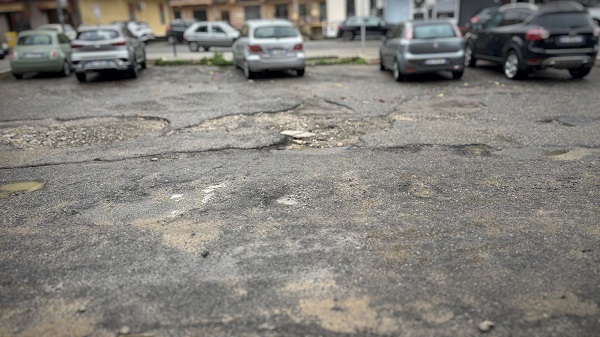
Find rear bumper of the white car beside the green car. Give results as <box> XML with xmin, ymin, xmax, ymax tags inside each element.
<box><xmin>72</xmin><ymin>51</ymin><xmax>132</xmax><ymax>72</ymax></box>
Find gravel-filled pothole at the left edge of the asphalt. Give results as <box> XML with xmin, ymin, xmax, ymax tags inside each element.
<box><xmin>0</xmin><ymin>117</ymin><xmax>169</xmax><ymax>149</ymax></box>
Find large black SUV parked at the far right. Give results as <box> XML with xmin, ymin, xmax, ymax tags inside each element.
<box><xmin>465</xmin><ymin>2</ymin><xmax>600</xmax><ymax>79</ymax></box>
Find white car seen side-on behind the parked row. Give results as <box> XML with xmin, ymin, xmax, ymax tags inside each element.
<box><xmin>183</xmin><ymin>21</ymin><xmax>240</xmax><ymax>51</ymax></box>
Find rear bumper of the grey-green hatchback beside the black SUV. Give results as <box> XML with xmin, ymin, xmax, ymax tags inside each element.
<box><xmin>400</xmin><ymin>50</ymin><xmax>465</xmax><ymax>74</ymax></box>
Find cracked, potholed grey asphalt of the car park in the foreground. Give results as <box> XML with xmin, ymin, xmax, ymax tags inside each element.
<box><xmin>0</xmin><ymin>65</ymin><xmax>600</xmax><ymax>337</ymax></box>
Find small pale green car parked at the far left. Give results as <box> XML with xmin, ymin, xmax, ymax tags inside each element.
<box><xmin>10</xmin><ymin>30</ymin><xmax>71</xmax><ymax>79</ymax></box>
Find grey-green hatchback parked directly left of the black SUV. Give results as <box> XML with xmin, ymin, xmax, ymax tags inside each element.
<box><xmin>379</xmin><ymin>21</ymin><xmax>464</xmax><ymax>81</ymax></box>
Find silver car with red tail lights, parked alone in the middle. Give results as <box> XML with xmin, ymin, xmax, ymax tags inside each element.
<box><xmin>232</xmin><ymin>19</ymin><xmax>306</xmax><ymax>79</ymax></box>
